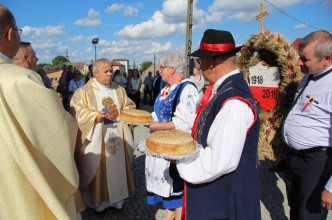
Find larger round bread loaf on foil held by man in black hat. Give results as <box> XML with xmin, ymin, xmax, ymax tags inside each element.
<box><xmin>146</xmin><ymin>130</ymin><xmax>196</xmax><ymax>156</ymax></box>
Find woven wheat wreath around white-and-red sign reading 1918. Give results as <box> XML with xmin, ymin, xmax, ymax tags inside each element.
<box><xmin>237</xmin><ymin>32</ymin><xmax>302</xmax><ymax>160</ymax></box>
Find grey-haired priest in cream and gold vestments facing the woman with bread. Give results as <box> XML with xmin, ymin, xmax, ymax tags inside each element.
<box><xmin>70</xmin><ymin>59</ymin><xmax>135</xmax><ymax>212</ymax></box>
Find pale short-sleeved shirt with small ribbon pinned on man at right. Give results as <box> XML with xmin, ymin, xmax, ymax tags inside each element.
<box><xmin>283</xmin><ymin>66</ymin><xmax>332</xmax><ymax>150</ymax></box>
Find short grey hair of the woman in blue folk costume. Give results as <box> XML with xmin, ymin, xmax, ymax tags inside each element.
<box><xmin>159</xmin><ymin>50</ymin><xmax>186</xmax><ymax>76</ymax></box>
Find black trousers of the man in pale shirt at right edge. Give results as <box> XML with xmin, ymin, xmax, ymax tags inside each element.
<box><xmin>285</xmin><ymin>148</ymin><xmax>332</xmax><ymax>220</ymax></box>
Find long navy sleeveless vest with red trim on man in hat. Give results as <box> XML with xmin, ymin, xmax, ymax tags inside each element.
<box><xmin>186</xmin><ymin>73</ymin><xmax>261</xmax><ymax>220</ymax></box>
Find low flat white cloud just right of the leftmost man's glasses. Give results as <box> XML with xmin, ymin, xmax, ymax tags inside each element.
<box><xmin>22</xmin><ymin>24</ymin><xmax>65</xmax><ymax>38</ymax></box>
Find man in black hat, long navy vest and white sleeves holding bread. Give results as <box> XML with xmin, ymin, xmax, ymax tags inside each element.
<box><xmin>177</xmin><ymin>29</ymin><xmax>261</xmax><ymax>220</ymax></box>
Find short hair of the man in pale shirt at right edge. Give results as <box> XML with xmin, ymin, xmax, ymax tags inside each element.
<box><xmin>299</xmin><ymin>30</ymin><xmax>332</xmax><ymax>59</ymax></box>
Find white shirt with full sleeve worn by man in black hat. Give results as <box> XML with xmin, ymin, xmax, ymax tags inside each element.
<box><xmin>177</xmin><ymin>70</ymin><xmax>254</xmax><ymax>184</ymax></box>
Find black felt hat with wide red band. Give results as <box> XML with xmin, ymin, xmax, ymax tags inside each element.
<box><xmin>190</xmin><ymin>29</ymin><xmax>242</xmax><ymax>57</ymax></box>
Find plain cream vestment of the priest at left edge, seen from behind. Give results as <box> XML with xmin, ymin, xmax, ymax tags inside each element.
<box><xmin>0</xmin><ymin>54</ymin><xmax>78</xmax><ymax>219</ymax></box>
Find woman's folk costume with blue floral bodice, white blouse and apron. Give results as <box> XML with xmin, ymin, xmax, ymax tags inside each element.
<box><xmin>145</xmin><ymin>80</ymin><xmax>199</xmax><ymax>209</ymax></box>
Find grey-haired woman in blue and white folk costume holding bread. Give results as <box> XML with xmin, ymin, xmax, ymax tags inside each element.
<box><xmin>145</xmin><ymin>51</ymin><xmax>199</xmax><ymax>219</ymax></box>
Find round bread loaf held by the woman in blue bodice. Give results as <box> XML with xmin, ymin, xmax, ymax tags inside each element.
<box><xmin>120</xmin><ymin>109</ymin><xmax>153</xmax><ymax>124</ymax></box>
